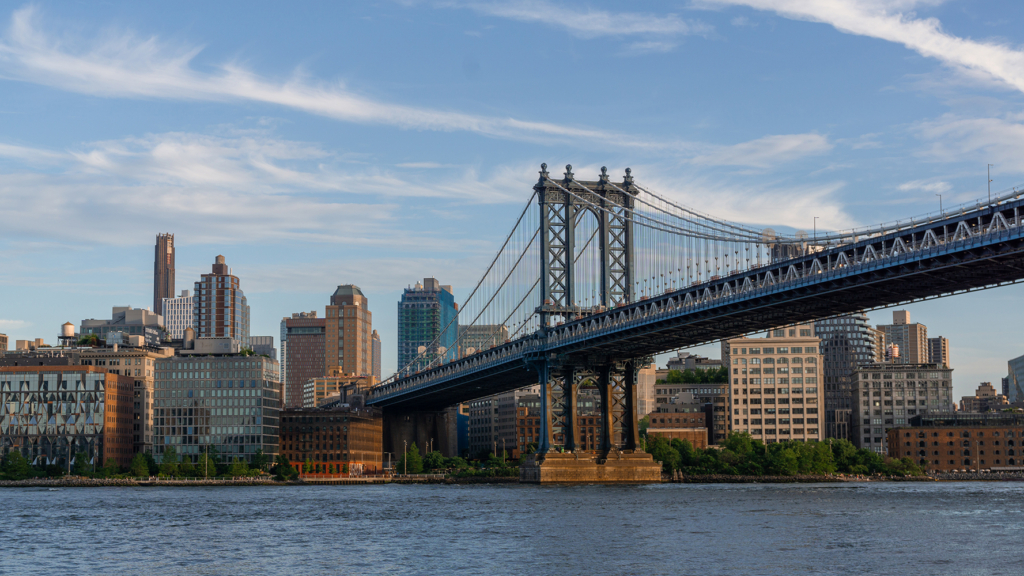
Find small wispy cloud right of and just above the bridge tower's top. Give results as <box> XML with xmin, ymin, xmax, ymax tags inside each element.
<box><xmin>690</xmin><ymin>133</ymin><xmax>833</xmax><ymax>168</ymax></box>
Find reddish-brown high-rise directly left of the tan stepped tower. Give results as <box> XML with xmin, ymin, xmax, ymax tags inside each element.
<box><xmin>285</xmin><ymin>311</ymin><xmax>327</xmax><ymax>408</ymax></box>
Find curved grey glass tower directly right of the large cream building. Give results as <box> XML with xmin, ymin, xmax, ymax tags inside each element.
<box><xmin>814</xmin><ymin>314</ymin><xmax>884</xmax><ymax>440</ymax></box>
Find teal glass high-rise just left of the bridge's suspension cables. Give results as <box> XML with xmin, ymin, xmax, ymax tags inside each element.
<box><xmin>398</xmin><ymin>278</ymin><xmax>459</xmax><ymax>373</ymax></box>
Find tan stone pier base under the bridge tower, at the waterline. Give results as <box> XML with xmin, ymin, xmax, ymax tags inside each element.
<box><xmin>519</xmin><ymin>452</ymin><xmax>662</xmax><ymax>484</ymax></box>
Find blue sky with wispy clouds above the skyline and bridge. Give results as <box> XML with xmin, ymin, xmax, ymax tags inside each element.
<box><xmin>0</xmin><ymin>0</ymin><xmax>1024</xmax><ymax>395</ymax></box>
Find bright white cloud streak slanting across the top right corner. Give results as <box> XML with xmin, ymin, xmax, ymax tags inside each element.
<box><xmin>701</xmin><ymin>0</ymin><xmax>1024</xmax><ymax>91</ymax></box>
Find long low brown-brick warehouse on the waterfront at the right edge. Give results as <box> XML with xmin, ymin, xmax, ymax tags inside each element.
<box><xmin>886</xmin><ymin>412</ymin><xmax>1024</xmax><ymax>472</ymax></box>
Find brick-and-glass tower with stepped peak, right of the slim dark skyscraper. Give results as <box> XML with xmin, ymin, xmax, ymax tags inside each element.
<box><xmin>193</xmin><ymin>255</ymin><xmax>252</xmax><ymax>348</ymax></box>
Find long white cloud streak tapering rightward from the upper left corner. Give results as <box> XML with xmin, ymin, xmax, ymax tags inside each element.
<box><xmin>0</xmin><ymin>6</ymin><xmax>685</xmax><ymax>151</ymax></box>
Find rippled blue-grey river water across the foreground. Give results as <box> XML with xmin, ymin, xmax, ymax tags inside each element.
<box><xmin>0</xmin><ymin>483</ymin><xmax>1024</xmax><ymax>576</ymax></box>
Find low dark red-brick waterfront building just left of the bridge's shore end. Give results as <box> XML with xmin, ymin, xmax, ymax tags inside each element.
<box><xmin>281</xmin><ymin>403</ymin><xmax>384</xmax><ymax>476</ymax></box>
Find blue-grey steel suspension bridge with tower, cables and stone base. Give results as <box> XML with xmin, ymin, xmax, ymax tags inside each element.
<box><xmin>369</xmin><ymin>165</ymin><xmax>1024</xmax><ymax>483</ymax></box>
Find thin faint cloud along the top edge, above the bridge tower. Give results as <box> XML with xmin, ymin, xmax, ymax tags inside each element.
<box><xmin>448</xmin><ymin>0</ymin><xmax>712</xmax><ymax>38</ymax></box>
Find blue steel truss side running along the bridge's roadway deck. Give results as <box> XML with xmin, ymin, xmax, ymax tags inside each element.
<box><xmin>371</xmin><ymin>200</ymin><xmax>1024</xmax><ymax>403</ymax></box>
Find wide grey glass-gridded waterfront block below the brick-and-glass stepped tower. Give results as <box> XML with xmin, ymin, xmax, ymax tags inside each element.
<box><xmin>154</xmin><ymin>338</ymin><xmax>282</xmax><ymax>462</ymax></box>
